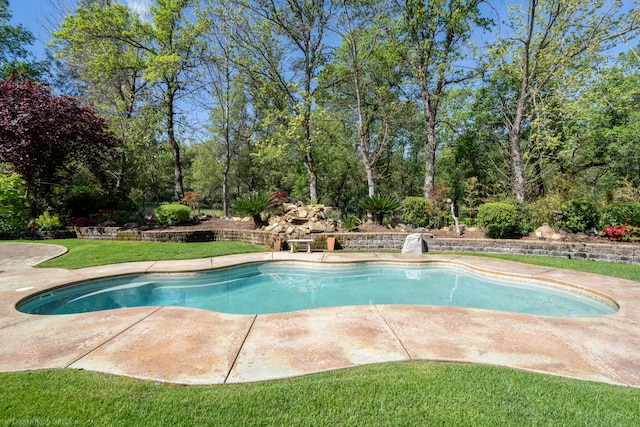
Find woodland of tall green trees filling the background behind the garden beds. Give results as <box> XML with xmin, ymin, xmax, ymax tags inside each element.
<box><xmin>0</xmin><ymin>0</ymin><xmax>640</xmax><ymax>234</ymax></box>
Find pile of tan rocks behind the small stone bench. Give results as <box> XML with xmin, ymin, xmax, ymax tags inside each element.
<box><xmin>264</xmin><ymin>202</ymin><xmax>337</xmax><ymax>235</ymax></box>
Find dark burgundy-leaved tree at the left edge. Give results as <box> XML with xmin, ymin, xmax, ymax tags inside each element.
<box><xmin>0</xmin><ymin>79</ymin><xmax>117</xmax><ymax>216</ymax></box>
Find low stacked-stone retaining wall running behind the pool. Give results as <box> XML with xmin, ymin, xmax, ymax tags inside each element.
<box><xmin>71</xmin><ymin>227</ymin><xmax>640</xmax><ymax>265</ymax></box>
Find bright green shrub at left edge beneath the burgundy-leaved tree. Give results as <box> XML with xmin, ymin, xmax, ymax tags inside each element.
<box><xmin>0</xmin><ymin>174</ymin><xmax>29</xmax><ymax>232</ymax></box>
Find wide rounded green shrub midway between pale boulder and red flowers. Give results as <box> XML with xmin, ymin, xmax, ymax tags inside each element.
<box><xmin>478</xmin><ymin>201</ymin><xmax>530</xmax><ymax>239</ymax></box>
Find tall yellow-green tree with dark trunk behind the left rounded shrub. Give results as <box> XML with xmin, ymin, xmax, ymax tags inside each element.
<box><xmin>51</xmin><ymin>0</ymin><xmax>156</xmax><ymax>196</ymax></box>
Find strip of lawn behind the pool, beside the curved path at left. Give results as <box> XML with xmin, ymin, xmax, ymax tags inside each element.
<box><xmin>31</xmin><ymin>239</ymin><xmax>264</xmax><ymax>270</ymax></box>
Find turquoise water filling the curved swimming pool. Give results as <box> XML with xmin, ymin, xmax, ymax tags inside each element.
<box><xmin>18</xmin><ymin>262</ymin><xmax>616</xmax><ymax>317</ymax></box>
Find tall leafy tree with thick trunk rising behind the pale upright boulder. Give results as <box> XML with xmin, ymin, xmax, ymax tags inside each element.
<box><xmin>383</xmin><ymin>0</ymin><xmax>491</xmax><ymax>198</ymax></box>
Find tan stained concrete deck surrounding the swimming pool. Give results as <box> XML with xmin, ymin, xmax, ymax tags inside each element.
<box><xmin>0</xmin><ymin>243</ymin><xmax>640</xmax><ymax>387</ymax></box>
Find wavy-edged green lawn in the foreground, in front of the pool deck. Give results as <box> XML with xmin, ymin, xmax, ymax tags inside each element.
<box><xmin>0</xmin><ymin>362</ymin><xmax>640</xmax><ymax>426</ymax></box>
